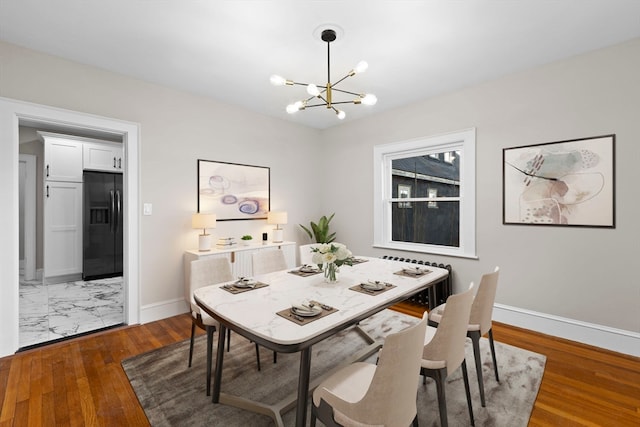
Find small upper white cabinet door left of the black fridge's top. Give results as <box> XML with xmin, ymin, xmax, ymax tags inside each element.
<box><xmin>44</xmin><ymin>137</ymin><xmax>82</xmax><ymax>182</ymax></box>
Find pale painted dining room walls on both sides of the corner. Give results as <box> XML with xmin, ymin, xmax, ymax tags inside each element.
<box><xmin>0</xmin><ymin>40</ymin><xmax>640</xmax><ymax>356</ymax></box>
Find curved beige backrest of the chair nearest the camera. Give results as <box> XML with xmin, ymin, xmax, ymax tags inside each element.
<box><xmin>324</xmin><ymin>312</ymin><xmax>427</xmax><ymax>427</ymax></box>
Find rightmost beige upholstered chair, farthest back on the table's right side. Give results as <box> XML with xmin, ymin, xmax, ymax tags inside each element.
<box><xmin>429</xmin><ymin>267</ymin><xmax>500</xmax><ymax>406</ymax></box>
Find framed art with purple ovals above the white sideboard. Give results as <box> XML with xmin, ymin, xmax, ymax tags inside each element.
<box><xmin>198</xmin><ymin>159</ymin><xmax>271</xmax><ymax>221</ymax></box>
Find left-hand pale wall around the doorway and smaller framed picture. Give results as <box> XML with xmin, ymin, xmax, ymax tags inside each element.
<box><xmin>0</xmin><ymin>42</ymin><xmax>321</xmax><ymax>356</ymax></box>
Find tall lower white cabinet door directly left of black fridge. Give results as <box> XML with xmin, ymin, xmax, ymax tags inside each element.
<box><xmin>44</xmin><ymin>181</ymin><xmax>82</xmax><ymax>277</ymax></box>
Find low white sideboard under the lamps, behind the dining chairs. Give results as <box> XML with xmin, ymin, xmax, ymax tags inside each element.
<box><xmin>184</xmin><ymin>242</ymin><xmax>297</xmax><ymax>290</ymax></box>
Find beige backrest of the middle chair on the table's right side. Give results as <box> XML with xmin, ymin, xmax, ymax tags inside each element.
<box><xmin>422</xmin><ymin>282</ymin><xmax>473</xmax><ymax>375</ymax></box>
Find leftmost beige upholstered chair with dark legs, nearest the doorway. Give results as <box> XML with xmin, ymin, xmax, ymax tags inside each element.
<box><xmin>185</xmin><ymin>257</ymin><xmax>260</xmax><ymax>396</ymax></box>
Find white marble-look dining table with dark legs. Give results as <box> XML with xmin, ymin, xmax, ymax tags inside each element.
<box><xmin>194</xmin><ymin>257</ymin><xmax>448</xmax><ymax>427</ymax></box>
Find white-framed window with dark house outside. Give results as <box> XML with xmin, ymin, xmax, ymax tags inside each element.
<box><xmin>374</xmin><ymin>129</ymin><xmax>476</xmax><ymax>257</ymax></box>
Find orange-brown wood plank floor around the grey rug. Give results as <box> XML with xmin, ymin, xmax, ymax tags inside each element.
<box><xmin>0</xmin><ymin>303</ymin><xmax>640</xmax><ymax>427</ymax></box>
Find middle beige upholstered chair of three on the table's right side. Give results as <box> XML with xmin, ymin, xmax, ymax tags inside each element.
<box><xmin>420</xmin><ymin>283</ymin><xmax>474</xmax><ymax>427</ymax></box>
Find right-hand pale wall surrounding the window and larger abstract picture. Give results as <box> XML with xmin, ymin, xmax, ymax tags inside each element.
<box><xmin>322</xmin><ymin>39</ymin><xmax>640</xmax><ymax>338</ymax></box>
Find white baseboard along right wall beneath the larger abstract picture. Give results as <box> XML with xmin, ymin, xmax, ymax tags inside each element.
<box><xmin>493</xmin><ymin>304</ymin><xmax>640</xmax><ymax>357</ymax></box>
